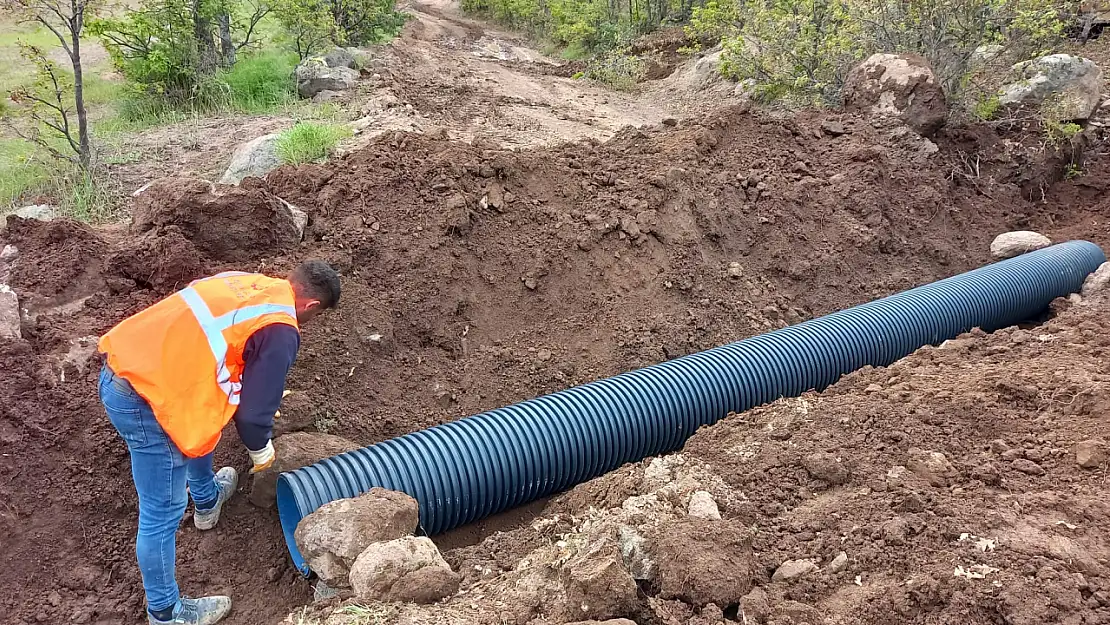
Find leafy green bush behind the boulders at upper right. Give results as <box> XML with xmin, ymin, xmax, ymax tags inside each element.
<box><xmin>719</xmin><ymin>0</ymin><xmax>1073</xmax><ymax>107</ymax></box>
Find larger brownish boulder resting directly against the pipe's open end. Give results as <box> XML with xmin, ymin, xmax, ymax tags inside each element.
<box><xmin>294</xmin><ymin>488</ymin><xmax>419</xmax><ymax>587</ymax></box>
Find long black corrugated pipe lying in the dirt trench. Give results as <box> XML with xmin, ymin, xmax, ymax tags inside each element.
<box><xmin>278</xmin><ymin>241</ymin><xmax>1106</xmax><ymax>575</ymax></box>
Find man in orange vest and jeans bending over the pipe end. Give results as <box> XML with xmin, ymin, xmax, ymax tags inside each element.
<box><xmin>99</xmin><ymin>261</ymin><xmax>340</xmax><ymax>625</ymax></box>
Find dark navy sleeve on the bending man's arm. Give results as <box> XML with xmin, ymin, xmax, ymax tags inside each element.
<box><xmin>234</xmin><ymin>323</ymin><xmax>301</xmax><ymax>452</ymax></box>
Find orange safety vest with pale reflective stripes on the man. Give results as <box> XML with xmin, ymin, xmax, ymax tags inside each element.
<box><xmin>100</xmin><ymin>272</ymin><xmax>299</xmax><ymax>457</ymax></box>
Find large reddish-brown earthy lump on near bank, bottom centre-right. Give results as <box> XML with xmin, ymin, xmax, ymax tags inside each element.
<box><xmin>648</xmin><ymin>517</ymin><xmax>754</xmax><ymax>607</ymax></box>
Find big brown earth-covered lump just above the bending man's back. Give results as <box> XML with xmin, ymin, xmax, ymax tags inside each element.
<box><xmin>131</xmin><ymin>178</ymin><xmax>304</xmax><ymax>261</ymax></box>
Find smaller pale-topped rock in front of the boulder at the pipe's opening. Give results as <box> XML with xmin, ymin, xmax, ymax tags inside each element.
<box><xmin>350</xmin><ymin>536</ymin><xmax>460</xmax><ymax>603</ymax></box>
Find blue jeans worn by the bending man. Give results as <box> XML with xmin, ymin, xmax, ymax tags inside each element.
<box><xmin>100</xmin><ymin>365</ymin><xmax>220</xmax><ymax>611</ymax></box>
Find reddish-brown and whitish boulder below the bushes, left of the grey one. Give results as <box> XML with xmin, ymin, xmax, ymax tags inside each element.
<box><xmin>844</xmin><ymin>54</ymin><xmax>948</xmax><ymax>137</ymax></box>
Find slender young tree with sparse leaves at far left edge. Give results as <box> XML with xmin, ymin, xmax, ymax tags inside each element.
<box><xmin>3</xmin><ymin>0</ymin><xmax>93</xmax><ymax>169</ymax></box>
